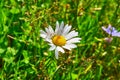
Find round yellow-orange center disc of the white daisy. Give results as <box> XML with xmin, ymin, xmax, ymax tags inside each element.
<box><xmin>52</xmin><ymin>35</ymin><xmax>66</xmax><ymax>46</ymax></box>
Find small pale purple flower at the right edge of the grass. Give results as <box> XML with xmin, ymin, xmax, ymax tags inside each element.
<box><xmin>102</xmin><ymin>24</ymin><xmax>120</xmax><ymax>37</ymax></box>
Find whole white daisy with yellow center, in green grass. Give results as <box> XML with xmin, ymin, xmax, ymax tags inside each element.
<box><xmin>40</xmin><ymin>22</ymin><xmax>81</xmax><ymax>59</ymax></box>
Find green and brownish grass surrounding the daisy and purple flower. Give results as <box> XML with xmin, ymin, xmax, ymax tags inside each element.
<box><xmin>0</xmin><ymin>0</ymin><xmax>120</xmax><ymax>80</ymax></box>
